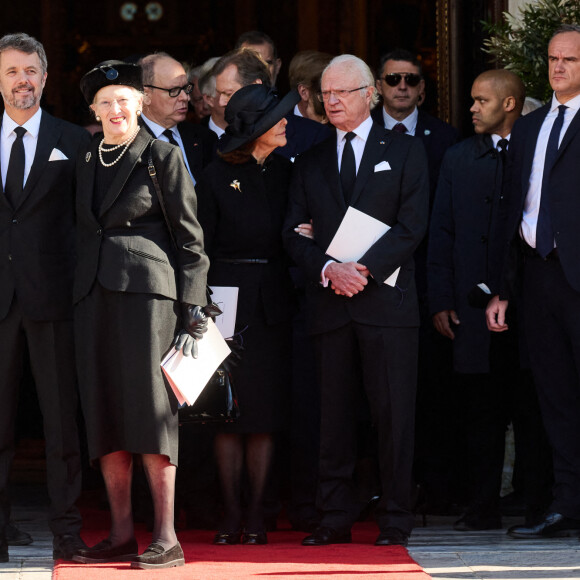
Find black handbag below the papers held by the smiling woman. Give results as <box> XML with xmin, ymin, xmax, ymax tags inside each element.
<box><xmin>178</xmin><ymin>363</ymin><xmax>240</xmax><ymax>425</ymax></box>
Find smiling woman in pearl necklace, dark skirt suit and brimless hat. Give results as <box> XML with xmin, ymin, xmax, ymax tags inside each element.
<box><xmin>74</xmin><ymin>61</ymin><xmax>208</xmax><ymax>568</ymax></box>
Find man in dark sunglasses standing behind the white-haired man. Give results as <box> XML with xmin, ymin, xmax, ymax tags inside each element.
<box><xmin>372</xmin><ymin>49</ymin><xmax>460</xmax><ymax>513</ymax></box>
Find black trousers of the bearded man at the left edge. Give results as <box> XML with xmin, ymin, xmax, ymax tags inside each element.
<box><xmin>0</xmin><ymin>299</ymin><xmax>81</xmax><ymax>535</ymax></box>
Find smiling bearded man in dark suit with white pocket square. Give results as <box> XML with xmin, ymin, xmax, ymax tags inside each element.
<box><xmin>0</xmin><ymin>33</ymin><xmax>90</xmax><ymax>560</ymax></box>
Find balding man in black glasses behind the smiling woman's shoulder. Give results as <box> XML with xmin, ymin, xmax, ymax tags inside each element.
<box><xmin>139</xmin><ymin>52</ymin><xmax>217</xmax><ymax>184</ymax></box>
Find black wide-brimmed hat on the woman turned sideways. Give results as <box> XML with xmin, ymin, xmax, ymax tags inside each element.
<box><xmin>220</xmin><ymin>84</ymin><xmax>300</xmax><ymax>153</ymax></box>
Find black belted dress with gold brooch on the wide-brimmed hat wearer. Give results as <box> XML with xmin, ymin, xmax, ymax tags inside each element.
<box><xmin>197</xmin><ymin>155</ymin><xmax>294</xmax><ymax>433</ymax></box>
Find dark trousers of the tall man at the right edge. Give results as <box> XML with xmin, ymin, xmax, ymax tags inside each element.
<box><xmin>523</xmin><ymin>256</ymin><xmax>580</xmax><ymax>520</ymax></box>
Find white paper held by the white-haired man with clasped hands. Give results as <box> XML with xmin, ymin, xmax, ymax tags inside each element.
<box><xmin>326</xmin><ymin>207</ymin><xmax>401</xmax><ymax>286</ymax></box>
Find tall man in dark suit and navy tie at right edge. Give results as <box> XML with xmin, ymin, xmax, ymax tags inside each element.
<box><xmin>487</xmin><ymin>25</ymin><xmax>580</xmax><ymax>538</ymax></box>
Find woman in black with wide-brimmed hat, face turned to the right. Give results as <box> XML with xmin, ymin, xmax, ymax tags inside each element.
<box><xmin>198</xmin><ymin>85</ymin><xmax>298</xmax><ymax>544</ymax></box>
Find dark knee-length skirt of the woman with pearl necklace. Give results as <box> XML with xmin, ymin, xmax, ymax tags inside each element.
<box><xmin>75</xmin><ymin>283</ymin><xmax>178</xmax><ymax>465</ymax></box>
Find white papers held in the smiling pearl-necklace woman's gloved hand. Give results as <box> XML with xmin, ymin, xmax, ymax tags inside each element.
<box><xmin>161</xmin><ymin>320</ymin><xmax>231</xmax><ymax>405</ymax></box>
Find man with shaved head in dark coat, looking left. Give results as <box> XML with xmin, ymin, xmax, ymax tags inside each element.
<box><xmin>427</xmin><ymin>70</ymin><xmax>550</xmax><ymax>531</ymax></box>
